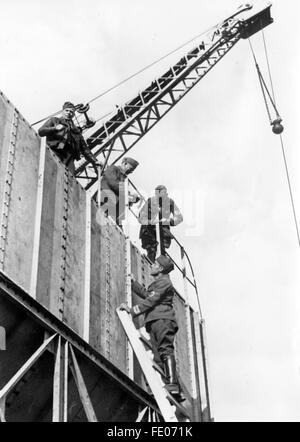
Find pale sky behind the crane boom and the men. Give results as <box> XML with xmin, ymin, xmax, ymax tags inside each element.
<box><xmin>0</xmin><ymin>0</ymin><xmax>300</xmax><ymax>421</ymax></box>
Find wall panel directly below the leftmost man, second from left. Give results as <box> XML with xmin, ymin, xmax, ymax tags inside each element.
<box><xmin>37</xmin><ymin>149</ymin><xmax>86</xmax><ymax>336</ymax></box>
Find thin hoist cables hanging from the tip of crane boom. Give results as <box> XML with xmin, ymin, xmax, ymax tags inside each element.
<box><xmin>248</xmin><ymin>36</ymin><xmax>300</xmax><ymax>248</ymax></box>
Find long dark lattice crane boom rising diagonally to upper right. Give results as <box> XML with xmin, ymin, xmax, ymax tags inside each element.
<box><xmin>76</xmin><ymin>3</ymin><xmax>273</xmax><ymax>189</ymax></box>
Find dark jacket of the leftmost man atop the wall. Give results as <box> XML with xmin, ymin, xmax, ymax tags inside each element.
<box><xmin>38</xmin><ymin>117</ymin><xmax>96</xmax><ymax>164</ymax></box>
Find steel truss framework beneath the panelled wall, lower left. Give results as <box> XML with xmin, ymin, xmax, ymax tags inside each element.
<box><xmin>0</xmin><ymin>272</ymin><xmax>160</xmax><ymax>422</ymax></box>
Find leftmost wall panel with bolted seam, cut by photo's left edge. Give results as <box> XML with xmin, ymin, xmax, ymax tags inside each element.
<box><xmin>0</xmin><ymin>90</ymin><xmax>40</xmax><ymax>290</ymax></box>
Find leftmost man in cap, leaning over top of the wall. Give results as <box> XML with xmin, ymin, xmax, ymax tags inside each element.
<box><xmin>38</xmin><ymin>101</ymin><xmax>99</xmax><ymax>174</ymax></box>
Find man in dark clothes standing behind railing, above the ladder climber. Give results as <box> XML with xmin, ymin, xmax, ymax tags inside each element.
<box><xmin>138</xmin><ymin>185</ymin><xmax>183</xmax><ymax>262</ymax></box>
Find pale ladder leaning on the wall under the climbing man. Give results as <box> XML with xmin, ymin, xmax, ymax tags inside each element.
<box><xmin>117</xmin><ymin>308</ymin><xmax>190</xmax><ymax>422</ymax></box>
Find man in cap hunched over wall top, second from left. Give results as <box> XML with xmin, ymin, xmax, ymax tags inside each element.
<box><xmin>101</xmin><ymin>157</ymin><xmax>139</xmax><ymax>227</ymax></box>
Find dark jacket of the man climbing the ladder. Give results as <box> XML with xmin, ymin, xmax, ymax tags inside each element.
<box><xmin>131</xmin><ymin>274</ymin><xmax>176</xmax><ymax>323</ymax></box>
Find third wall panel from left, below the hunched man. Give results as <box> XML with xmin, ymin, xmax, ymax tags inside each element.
<box><xmin>90</xmin><ymin>210</ymin><xmax>127</xmax><ymax>373</ymax></box>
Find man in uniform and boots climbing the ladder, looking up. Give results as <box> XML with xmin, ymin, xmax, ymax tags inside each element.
<box><xmin>120</xmin><ymin>255</ymin><xmax>184</xmax><ymax>401</ymax></box>
